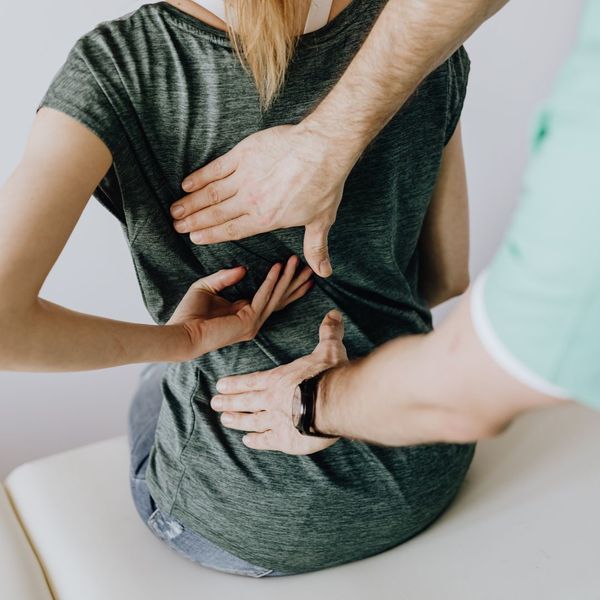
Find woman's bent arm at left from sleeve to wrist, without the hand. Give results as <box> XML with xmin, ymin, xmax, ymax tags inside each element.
<box><xmin>0</xmin><ymin>108</ymin><xmax>190</xmax><ymax>371</ymax></box>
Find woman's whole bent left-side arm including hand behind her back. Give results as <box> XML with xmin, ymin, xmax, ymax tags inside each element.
<box><xmin>0</xmin><ymin>108</ymin><xmax>309</xmax><ymax>371</ymax></box>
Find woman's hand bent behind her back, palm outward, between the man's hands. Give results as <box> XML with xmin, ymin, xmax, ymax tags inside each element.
<box><xmin>166</xmin><ymin>256</ymin><xmax>313</xmax><ymax>360</ymax></box>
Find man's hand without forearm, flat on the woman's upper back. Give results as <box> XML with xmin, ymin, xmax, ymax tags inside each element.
<box><xmin>171</xmin><ymin>125</ymin><xmax>349</xmax><ymax>277</ymax></box>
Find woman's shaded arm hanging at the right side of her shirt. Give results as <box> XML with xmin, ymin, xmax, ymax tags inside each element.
<box><xmin>419</xmin><ymin>124</ymin><xmax>469</xmax><ymax>308</ymax></box>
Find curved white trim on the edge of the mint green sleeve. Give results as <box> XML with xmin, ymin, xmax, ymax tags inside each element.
<box><xmin>471</xmin><ymin>271</ymin><xmax>571</xmax><ymax>400</ymax></box>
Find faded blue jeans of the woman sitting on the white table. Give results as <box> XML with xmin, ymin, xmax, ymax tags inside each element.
<box><xmin>128</xmin><ymin>363</ymin><xmax>286</xmax><ymax>577</ymax></box>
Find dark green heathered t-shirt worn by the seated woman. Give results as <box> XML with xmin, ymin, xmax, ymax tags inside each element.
<box><xmin>41</xmin><ymin>0</ymin><xmax>473</xmax><ymax>572</ymax></box>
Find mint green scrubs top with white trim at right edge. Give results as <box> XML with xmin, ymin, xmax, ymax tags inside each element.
<box><xmin>472</xmin><ymin>0</ymin><xmax>600</xmax><ymax>409</ymax></box>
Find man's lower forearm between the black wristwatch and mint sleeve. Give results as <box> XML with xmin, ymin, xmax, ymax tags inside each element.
<box><xmin>316</xmin><ymin>288</ymin><xmax>557</xmax><ymax>446</ymax></box>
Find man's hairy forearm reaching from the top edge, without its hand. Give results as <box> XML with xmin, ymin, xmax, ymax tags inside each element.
<box><xmin>302</xmin><ymin>0</ymin><xmax>508</xmax><ymax>165</ymax></box>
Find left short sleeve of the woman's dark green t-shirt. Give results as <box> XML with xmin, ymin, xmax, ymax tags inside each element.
<box><xmin>36</xmin><ymin>42</ymin><xmax>123</xmax><ymax>159</ymax></box>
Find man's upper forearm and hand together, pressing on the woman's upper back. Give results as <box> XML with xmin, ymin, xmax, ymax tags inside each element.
<box><xmin>171</xmin><ymin>0</ymin><xmax>507</xmax><ymax>277</ymax></box>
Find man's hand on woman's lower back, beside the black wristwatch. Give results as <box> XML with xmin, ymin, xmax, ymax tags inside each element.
<box><xmin>211</xmin><ymin>311</ymin><xmax>348</xmax><ymax>454</ymax></box>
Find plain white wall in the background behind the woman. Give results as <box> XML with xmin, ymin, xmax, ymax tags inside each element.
<box><xmin>0</xmin><ymin>0</ymin><xmax>581</xmax><ymax>478</ymax></box>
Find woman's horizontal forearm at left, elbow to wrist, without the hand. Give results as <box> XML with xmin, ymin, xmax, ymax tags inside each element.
<box><xmin>0</xmin><ymin>298</ymin><xmax>186</xmax><ymax>371</ymax></box>
